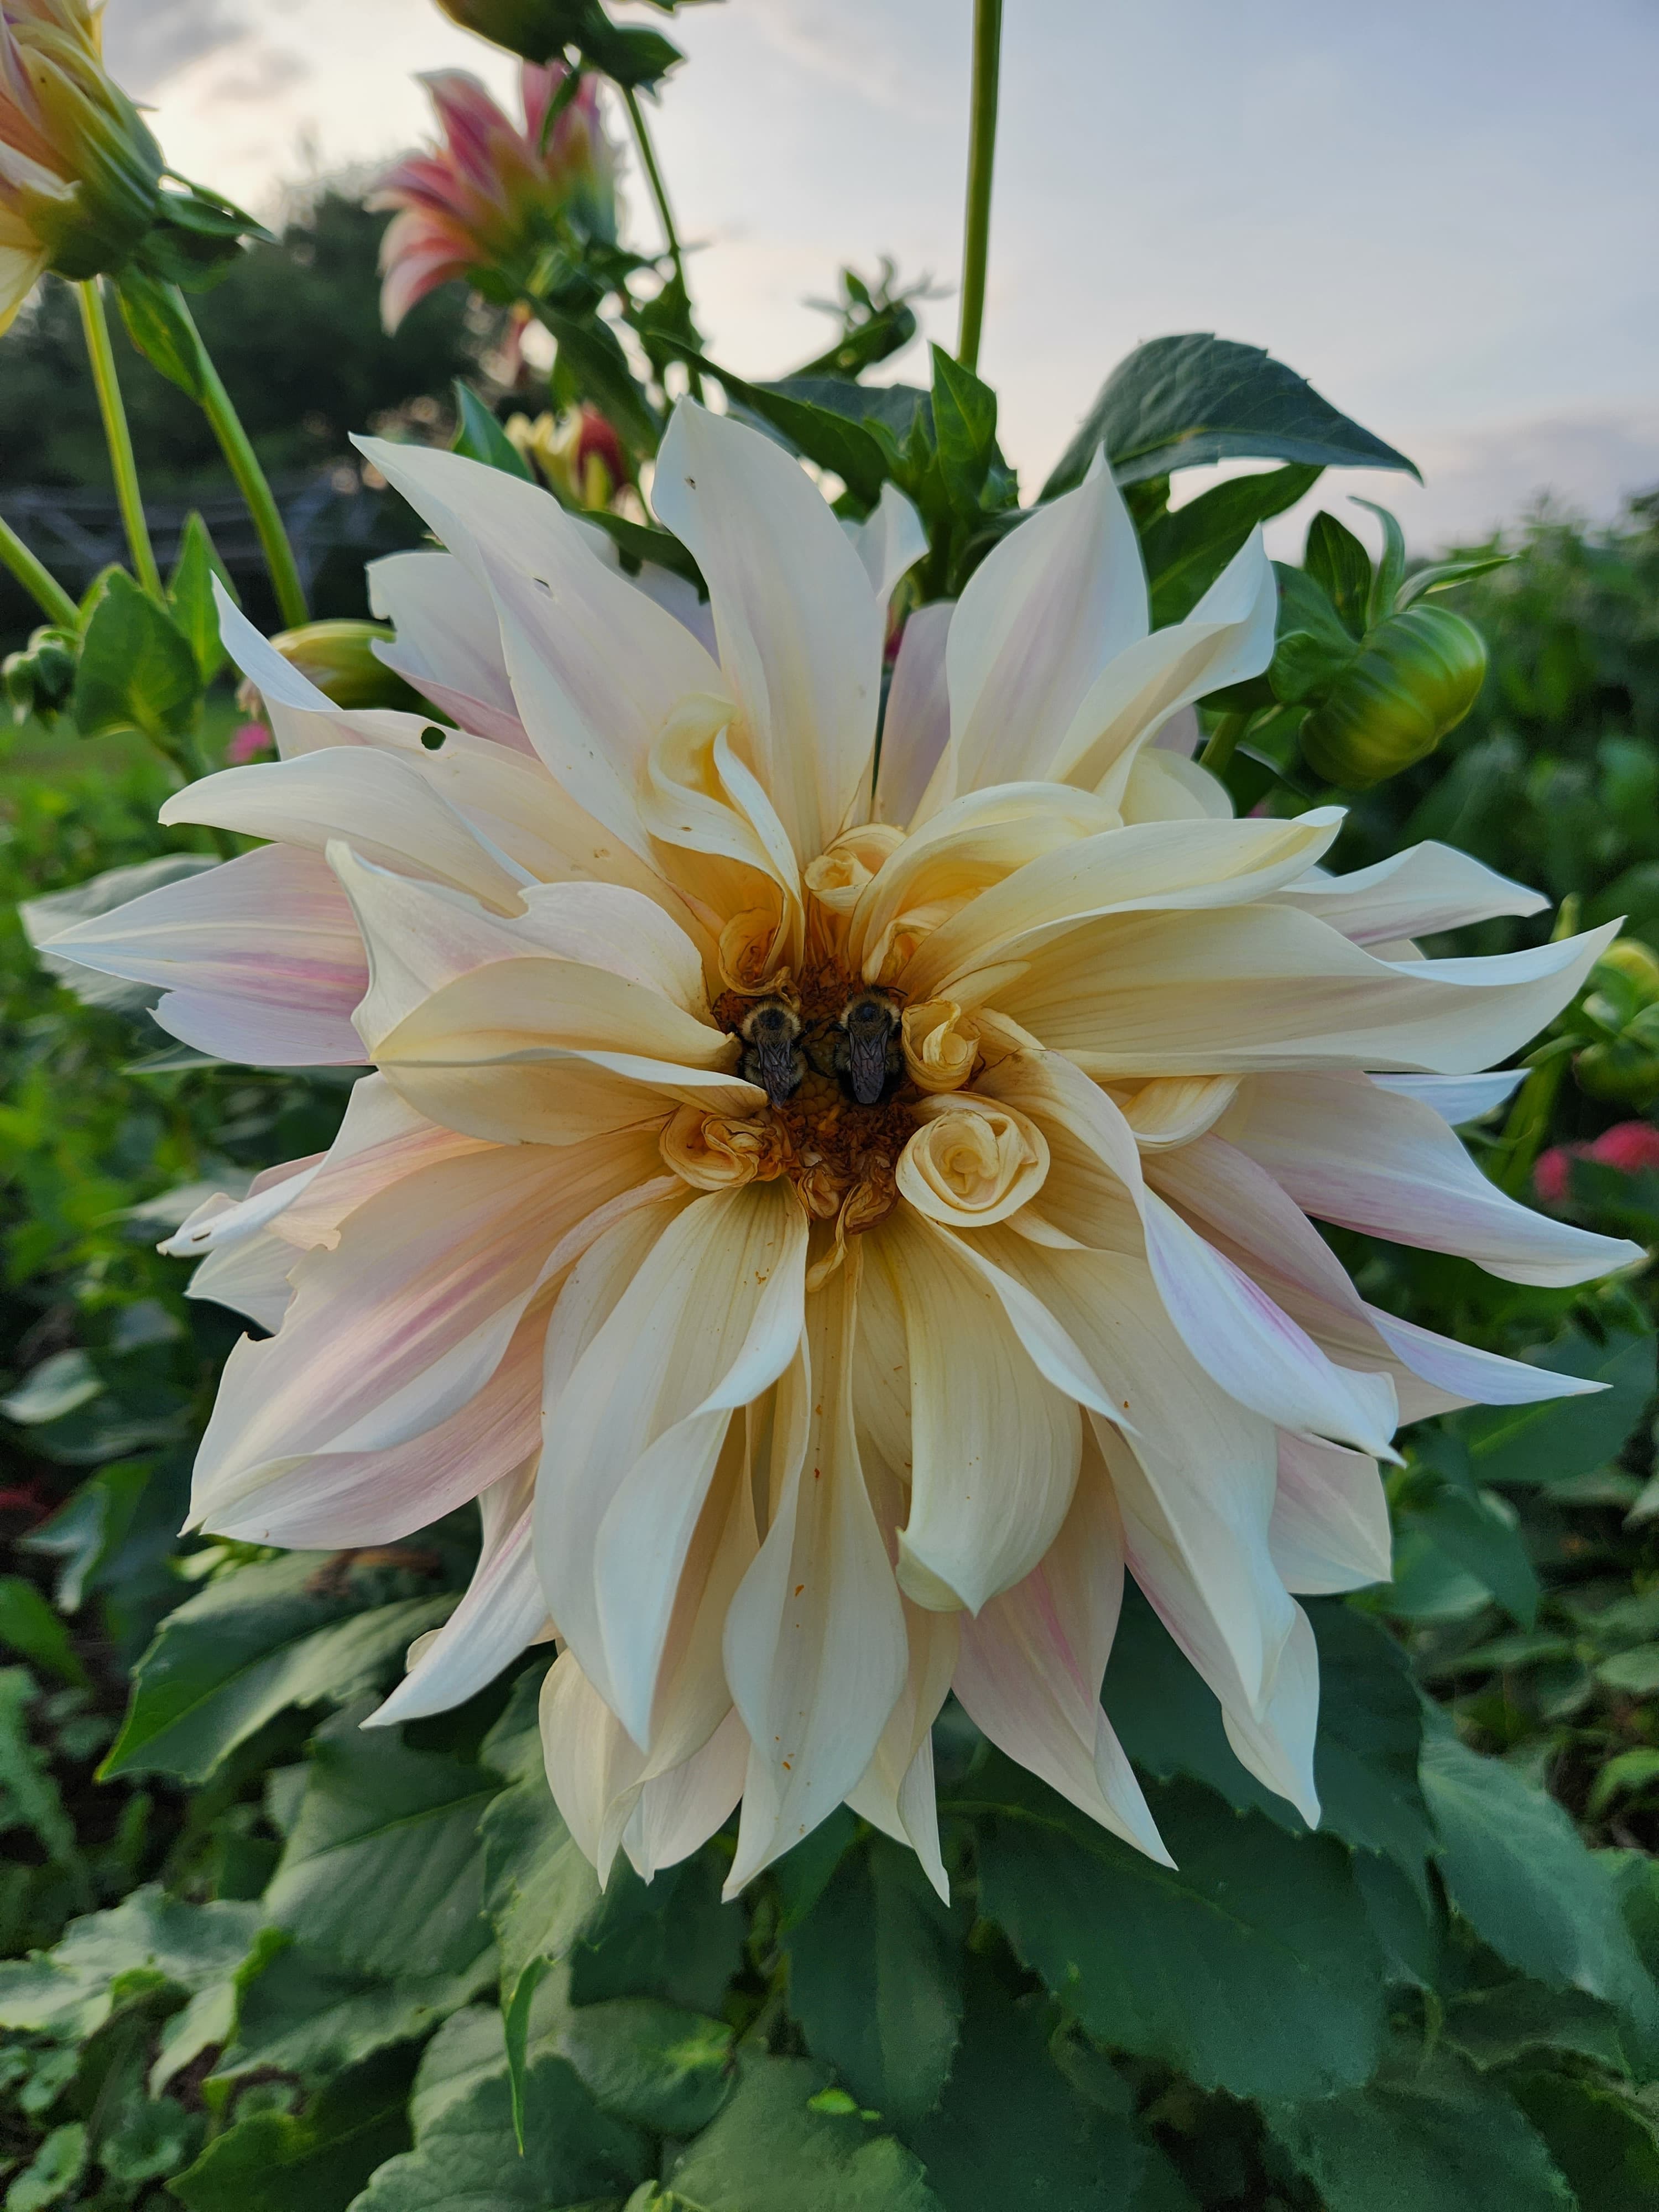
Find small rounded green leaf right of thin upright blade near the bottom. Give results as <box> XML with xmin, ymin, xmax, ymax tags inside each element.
<box><xmin>551</xmin><ymin>1997</ymin><xmax>732</xmax><ymax>2135</ymax></box>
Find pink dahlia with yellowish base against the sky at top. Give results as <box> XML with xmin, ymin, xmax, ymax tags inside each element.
<box><xmin>369</xmin><ymin>62</ymin><xmax>617</xmax><ymax>330</ymax></box>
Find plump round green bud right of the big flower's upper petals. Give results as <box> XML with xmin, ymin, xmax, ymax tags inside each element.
<box><xmin>1301</xmin><ymin>606</ymin><xmax>1486</xmax><ymax>790</ymax></box>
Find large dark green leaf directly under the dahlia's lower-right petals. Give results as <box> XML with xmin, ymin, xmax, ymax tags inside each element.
<box><xmin>969</xmin><ymin>1756</ymin><xmax>1385</xmax><ymax>2097</ymax></box>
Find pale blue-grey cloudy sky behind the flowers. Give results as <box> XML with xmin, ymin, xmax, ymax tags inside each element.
<box><xmin>106</xmin><ymin>0</ymin><xmax>1659</xmax><ymax>551</ymax></box>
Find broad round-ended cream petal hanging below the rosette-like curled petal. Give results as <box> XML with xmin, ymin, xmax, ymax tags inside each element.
<box><xmin>872</xmin><ymin>1208</ymin><xmax>1082</xmax><ymax>1613</ymax></box>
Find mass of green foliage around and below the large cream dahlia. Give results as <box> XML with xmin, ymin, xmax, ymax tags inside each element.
<box><xmin>0</xmin><ymin>229</ymin><xmax>1659</xmax><ymax>2212</ymax></box>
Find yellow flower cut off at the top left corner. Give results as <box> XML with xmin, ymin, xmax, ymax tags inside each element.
<box><xmin>0</xmin><ymin>0</ymin><xmax>161</xmax><ymax>330</ymax></box>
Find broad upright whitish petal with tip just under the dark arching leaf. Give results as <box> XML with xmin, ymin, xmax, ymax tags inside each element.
<box><xmin>947</xmin><ymin>458</ymin><xmax>1148</xmax><ymax>792</ymax></box>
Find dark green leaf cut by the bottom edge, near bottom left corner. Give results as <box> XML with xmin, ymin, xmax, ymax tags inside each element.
<box><xmin>168</xmin><ymin>2051</ymin><xmax>414</xmax><ymax>2212</ymax></box>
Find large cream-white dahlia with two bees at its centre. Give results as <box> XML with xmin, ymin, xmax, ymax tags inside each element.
<box><xmin>53</xmin><ymin>405</ymin><xmax>1637</xmax><ymax>1887</ymax></box>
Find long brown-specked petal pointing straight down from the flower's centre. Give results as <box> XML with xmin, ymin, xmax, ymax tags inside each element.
<box><xmin>726</xmin><ymin>1241</ymin><xmax>909</xmax><ymax>1896</ymax></box>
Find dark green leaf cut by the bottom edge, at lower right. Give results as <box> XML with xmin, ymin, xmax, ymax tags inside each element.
<box><xmin>1267</xmin><ymin>2059</ymin><xmax>1573</xmax><ymax>2212</ymax></box>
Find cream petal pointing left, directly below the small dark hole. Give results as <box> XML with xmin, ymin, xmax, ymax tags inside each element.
<box><xmin>161</xmin><ymin>745</ymin><xmax>522</xmax><ymax>914</ymax></box>
